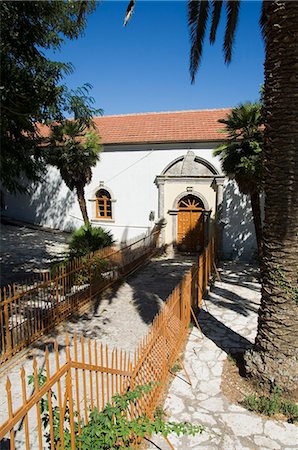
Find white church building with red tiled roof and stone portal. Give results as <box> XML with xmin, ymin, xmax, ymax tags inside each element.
<box><xmin>5</xmin><ymin>109</ymin><xmax>256</xmax><ymax>260</ymax></box>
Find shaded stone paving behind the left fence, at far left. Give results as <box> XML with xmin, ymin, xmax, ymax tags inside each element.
<box><xmin>0</xmin><ymin>223</ymin><xmax>70</xmax><ymax>286</ymax></box>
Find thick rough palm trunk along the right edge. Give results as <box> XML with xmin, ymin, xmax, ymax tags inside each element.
<box><xmin>246</xmin><ymin>0</ymin><xmax>298</xmax><ymax>396</ymax></box>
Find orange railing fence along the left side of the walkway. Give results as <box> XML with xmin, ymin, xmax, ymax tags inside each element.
<box><xmin>0</xmin><ymin>228</ymin><xmax>160</xmax><ymax>365</ymax></box>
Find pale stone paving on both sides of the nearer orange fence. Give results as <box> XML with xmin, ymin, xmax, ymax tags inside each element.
<box><xmin>0</xmin><ymin>236</ymin><xmax>297</xmax><ymax>450</ymax></box>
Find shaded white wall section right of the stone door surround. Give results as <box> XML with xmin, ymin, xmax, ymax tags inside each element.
<box><xmin>221</xmin><ymin>181</ymin><xmax>257</xmax><ymax>261</ymax></box>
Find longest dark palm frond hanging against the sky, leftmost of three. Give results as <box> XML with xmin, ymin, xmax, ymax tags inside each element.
<box><xmin>188</xmin><ymin>0</ymin><xmax>210</xmax><ymax>83</ymax></box>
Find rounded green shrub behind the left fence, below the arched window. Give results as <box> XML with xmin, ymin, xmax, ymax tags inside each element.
<box><xmin>69</xmin><ymin>225</ymin><xmax>114</xmax><ymax>258</ymax></box>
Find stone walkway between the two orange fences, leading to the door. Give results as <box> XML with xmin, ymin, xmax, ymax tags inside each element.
<box><xmin>0</xmin><ymin>255</ymin><xmax>194</xmax><ymax>450</ymax></box>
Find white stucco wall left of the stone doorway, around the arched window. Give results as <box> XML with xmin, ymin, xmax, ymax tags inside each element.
<box><xmin>5</xmin><ymin>146</ymin><xmax>219</xmax><ymax>236</ymax></box>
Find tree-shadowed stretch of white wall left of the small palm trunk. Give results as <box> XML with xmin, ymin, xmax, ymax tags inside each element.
<box><xmin>5</xmin><ymin>169</ymin><xmax>75</xmax><ymax>230</ymax></box>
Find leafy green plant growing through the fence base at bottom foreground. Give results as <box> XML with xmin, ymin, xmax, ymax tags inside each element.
<box><xmin>29</xmin><ymin>372</ymin><xmax>204</xmax><ymax>450</ymax></box>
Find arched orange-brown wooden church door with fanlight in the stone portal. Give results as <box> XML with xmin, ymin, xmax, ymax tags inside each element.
<box><xmin>177</xmin><ymin>194</ymin><xmax>204</xmax><ymax>251</ymax></box>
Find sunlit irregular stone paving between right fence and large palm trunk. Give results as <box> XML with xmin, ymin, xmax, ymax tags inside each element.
<box><xmin>148</xmin><ymin>264</ymin><xmax>298</xmax><ymax>450</ymax></box>
